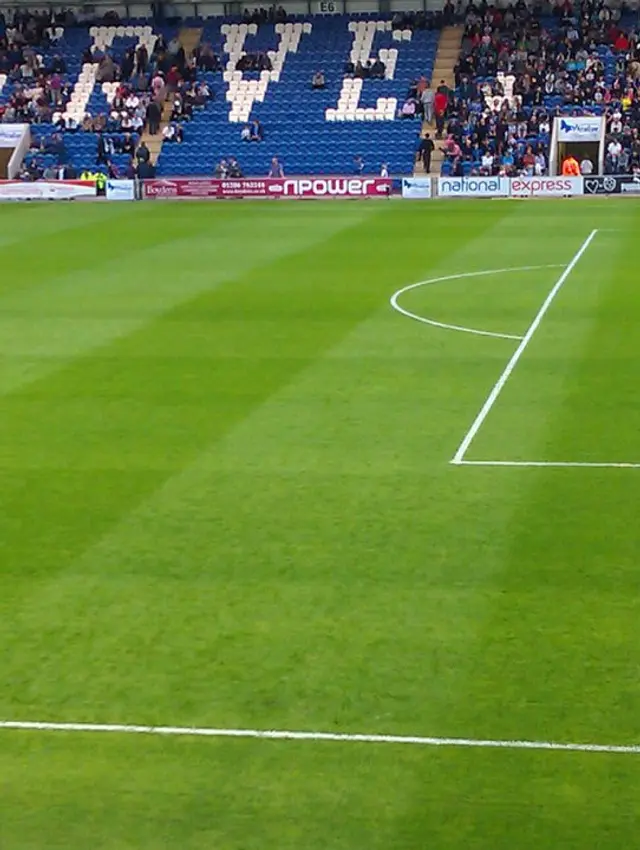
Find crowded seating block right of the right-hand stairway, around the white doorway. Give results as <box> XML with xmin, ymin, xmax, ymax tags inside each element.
<box><xmin>442</xmin><ymin>0</ymin><xmax>640</xmax><ymax>176</ymax></box>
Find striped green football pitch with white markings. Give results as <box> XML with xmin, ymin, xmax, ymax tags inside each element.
<box><xmin>0</xmin><ymin>198</ymin><xmax>640</xmax><ymax>850</ymax></box>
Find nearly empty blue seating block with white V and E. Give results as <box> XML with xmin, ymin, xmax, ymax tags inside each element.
<box><xmin>158</xmin><ymin>15</ymin><xmax>438</xmax><ymax>175</ymax></box>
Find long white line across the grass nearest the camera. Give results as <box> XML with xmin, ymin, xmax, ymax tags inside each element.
<box><xmin>0</xmin><ymin>720</ymin><xmax>640</xmax><ymax>755</ymax></box>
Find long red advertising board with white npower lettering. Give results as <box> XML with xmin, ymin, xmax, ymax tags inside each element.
<box><xmin>144</xmin><ymin>177</ymin><xmax>391</xmax><ymax>198</ymax></box>
